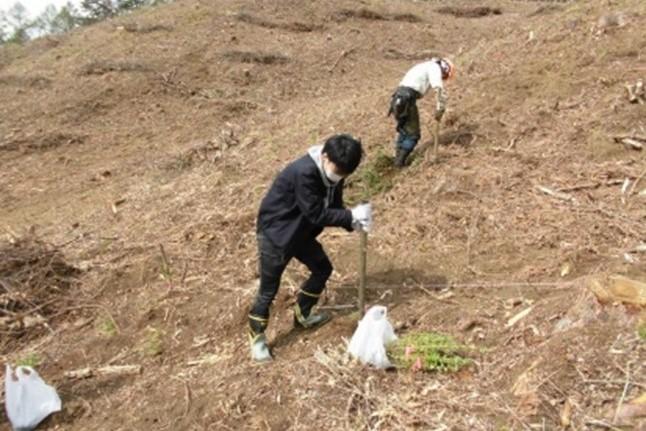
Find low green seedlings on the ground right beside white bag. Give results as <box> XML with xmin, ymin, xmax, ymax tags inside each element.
<box><xmin>388</xmin><ymin>332</ymin><xmax>473</xmax><ymax>372</ymax></box>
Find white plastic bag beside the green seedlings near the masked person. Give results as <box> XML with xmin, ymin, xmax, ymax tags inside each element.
<box><xmin>348</xmin><ymin>305</ymin><xmax>397</xmax><ymax>368</ymax></box>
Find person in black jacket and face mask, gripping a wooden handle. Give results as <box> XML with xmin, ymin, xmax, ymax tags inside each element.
<box><xmin>249</xmin><ymin>135</ymin><xmax>372</xmax><ymax>361</ymax></box>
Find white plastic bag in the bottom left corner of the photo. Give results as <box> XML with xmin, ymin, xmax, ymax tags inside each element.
<box><xmin>4</xmin><ymin>364</ymin><xmax>61</xmax><ymax>431</ymax></box>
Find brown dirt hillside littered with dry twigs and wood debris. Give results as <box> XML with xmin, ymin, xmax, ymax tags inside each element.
<box><xmin>0</xmin><ymin>0</ymin><xmax>646</xmax><ymax>430</ymax></box>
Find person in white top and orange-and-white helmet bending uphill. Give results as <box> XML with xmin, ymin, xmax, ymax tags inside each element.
<box><xmin>388</xmin><ymin>58</ymin><xmax>455</xmax><ymax>167</ymax></box>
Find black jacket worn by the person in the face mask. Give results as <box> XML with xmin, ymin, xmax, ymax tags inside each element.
<box><xmin>257</xmin><ymin>154</ymin><xmax>352</xmax><ymax>252</ymax></box>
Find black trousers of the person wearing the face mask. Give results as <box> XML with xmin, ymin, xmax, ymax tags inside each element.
<box><xmin>249</xmin><ymin>233</ymin><xmax>332</xmax><ymax>334</ymax></box>
